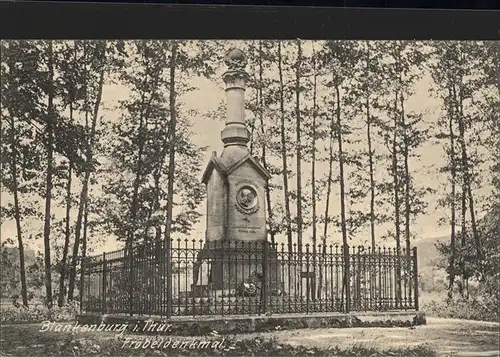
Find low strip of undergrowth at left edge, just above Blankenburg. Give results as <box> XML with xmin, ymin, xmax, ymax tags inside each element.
<box><xmin>0</xmin><ymin>302</ymin><xmax>79</xmax><ymax>325</ymax></box>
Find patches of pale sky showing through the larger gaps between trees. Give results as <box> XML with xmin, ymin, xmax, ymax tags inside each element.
<box><xmin>1</xmin><ymin>40</ymin><xmax>488</xmax><ymax>253</ymax></box>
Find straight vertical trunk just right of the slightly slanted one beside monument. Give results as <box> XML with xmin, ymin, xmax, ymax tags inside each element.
<box><xmin>295</xmin><ymin>40</ymin><xmax>302</xmax><ymax>254</ymax></box>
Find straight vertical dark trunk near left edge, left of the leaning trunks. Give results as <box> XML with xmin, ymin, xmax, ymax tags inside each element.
<box><xmin>43</xmin><ymin>40</ymin><xmax>55</xmax><ymax>309</ymax></box>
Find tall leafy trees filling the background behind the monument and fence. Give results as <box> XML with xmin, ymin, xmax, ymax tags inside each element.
<box><xmin>1</xmin><ymin>40</ymin><xmax>500</xmax><ymax>307</ymax></box>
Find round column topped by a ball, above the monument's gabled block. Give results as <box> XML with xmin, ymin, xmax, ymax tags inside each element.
<box><xmin>221</xmin><ymin>48</ymin><xmax>250</xmax><ymax>148</ymax></box>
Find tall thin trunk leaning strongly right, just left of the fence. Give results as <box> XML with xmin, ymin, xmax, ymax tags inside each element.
<box><xmin>68</xmin><ymin>42</ymin><xmax>106</xmax><ymax>301</ymax></box>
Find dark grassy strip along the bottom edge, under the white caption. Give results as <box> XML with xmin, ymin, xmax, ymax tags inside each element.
<box><xmin>0</xmin><ymin>324</ymin><xmax>435</xmax><ymax>357</ymax></box>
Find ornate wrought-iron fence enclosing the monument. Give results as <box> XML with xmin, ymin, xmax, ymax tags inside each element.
<box><xmin>80</xmin><ymin>239</ymin><xmax>418</xmax><ymax>318</ymax></box>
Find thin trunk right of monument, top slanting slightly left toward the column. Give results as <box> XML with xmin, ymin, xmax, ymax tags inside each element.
<box><xmin>278</xmin><ymin>41</ymin><xmax>293</xmax><ymax>256</ymax></box>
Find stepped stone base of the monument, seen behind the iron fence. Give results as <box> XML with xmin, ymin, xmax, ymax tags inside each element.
<box><xmin>193</xmin><ymin>241</ymin><xmax>282</xmax><ymax>290</ymax></box>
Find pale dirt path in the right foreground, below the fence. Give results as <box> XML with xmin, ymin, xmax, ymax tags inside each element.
<box><xmin>237</xmin><ymin>317</ymin><xmax>500</xmax><ymax>357</ymax></box>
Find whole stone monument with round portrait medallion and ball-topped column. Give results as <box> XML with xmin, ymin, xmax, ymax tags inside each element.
<box><xmin>193</xmin><ymin>49</ymin><xmax>279</xmax><ymax>291</ymax></box>
